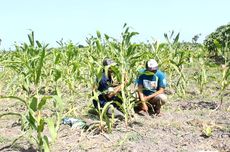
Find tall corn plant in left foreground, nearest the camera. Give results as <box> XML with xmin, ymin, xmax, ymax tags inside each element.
<box><xmin>1</xmin><ymin>32</ymin><xmax>63</xmax><ymax>151</ymax></box>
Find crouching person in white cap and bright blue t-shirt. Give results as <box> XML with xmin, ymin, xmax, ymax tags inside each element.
<box><xmin>138</xmin><ymin>59</ymin><xmax>167</xmax><ymax>115</ymax></box>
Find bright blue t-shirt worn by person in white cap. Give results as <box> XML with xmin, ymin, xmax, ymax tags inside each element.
<box><xmin>138</xmin><ymin>70</ymin><xmax>167</xmax><ymax>96</ymax></box>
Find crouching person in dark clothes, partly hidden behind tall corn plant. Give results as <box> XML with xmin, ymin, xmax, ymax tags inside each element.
<box><xmin>93</xmin><ymin>59</ymin><xmax>124</xmax><ymax>118</ymax></box>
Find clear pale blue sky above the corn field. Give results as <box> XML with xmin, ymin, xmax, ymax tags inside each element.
<box><xmin>0</xmin><ymin>0</ymin><xmax>230</xmax><ymax>49</ymax></box>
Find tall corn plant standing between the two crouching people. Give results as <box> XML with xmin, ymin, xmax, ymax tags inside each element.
<box><xmin>104</xmin><ymin>24</ymin><xmax>142</xmax><ymax>127</ymax></box>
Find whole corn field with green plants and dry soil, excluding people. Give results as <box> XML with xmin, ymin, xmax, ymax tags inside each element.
<box><xmin>0</xmin><ymin>27</ymin><xmax>230</xmax><ymax>152</ymax></box>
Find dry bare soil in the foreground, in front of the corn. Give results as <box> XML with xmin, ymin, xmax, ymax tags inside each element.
<box><xmin>0</xmin><ymin>92</ymin><xmax>230</xmax><ymax>152</ymax></box>
